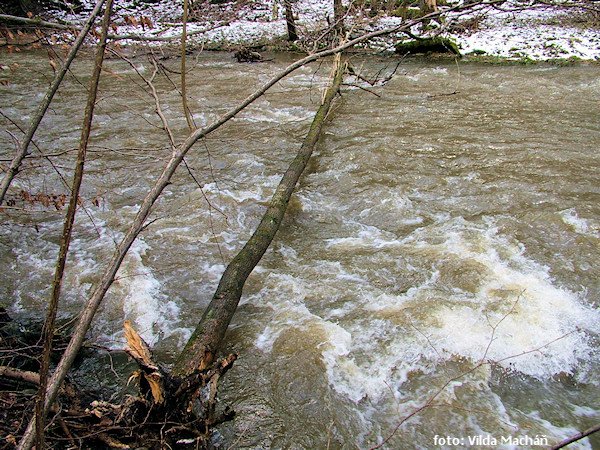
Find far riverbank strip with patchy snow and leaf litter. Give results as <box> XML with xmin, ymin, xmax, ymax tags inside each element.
<box><xmin>1</xmin><ymin>0</ymin><xmax>600</xmax><ymax>62</ymax></box>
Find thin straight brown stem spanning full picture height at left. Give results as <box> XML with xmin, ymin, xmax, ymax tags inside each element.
<box><xmin>21</xmin><ymin>0</ymin><xmax>113</xmax><ymax>449</ymax></box>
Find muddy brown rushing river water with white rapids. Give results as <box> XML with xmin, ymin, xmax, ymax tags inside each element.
<box><xmin>0</xmin><ymin>50</ymin><xmax>600</xmax><ymax>448</ymax></box>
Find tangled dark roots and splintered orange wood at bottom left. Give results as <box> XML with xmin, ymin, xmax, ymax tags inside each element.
<box><xmin>0</xmin><ymin>312</ymin><xmax>237</xmax><ymax>449</ymax></box>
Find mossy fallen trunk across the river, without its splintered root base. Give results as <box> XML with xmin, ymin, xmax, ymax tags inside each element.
<box><xmin>173</xmin><ymin>54</ymin><xmax>345</xmax><ymax>377</ymax></box>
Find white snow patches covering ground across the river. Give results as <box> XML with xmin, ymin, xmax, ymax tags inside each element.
<box><xmin>52</xmin><ymin>0</ymin><xmax>600</xmax><ymax>61</ymax></box>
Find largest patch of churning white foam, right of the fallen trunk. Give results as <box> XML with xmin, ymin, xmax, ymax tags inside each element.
<box><xmin>312</xmin><ymin>218</ymin><xmax>600</xmax><ymax>401</ymax></box>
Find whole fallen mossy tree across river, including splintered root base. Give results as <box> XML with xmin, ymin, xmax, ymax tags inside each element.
<box><xmin>41</xmin><ymin>55</ymin><xmax>345</xmax><ymax>448</ymax></box>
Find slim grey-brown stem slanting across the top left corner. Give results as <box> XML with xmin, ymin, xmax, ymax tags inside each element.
<box><xmin>0</xmin><ymin>0</ymin><xmax>106</xmax><ymax>205</ymax></box>
